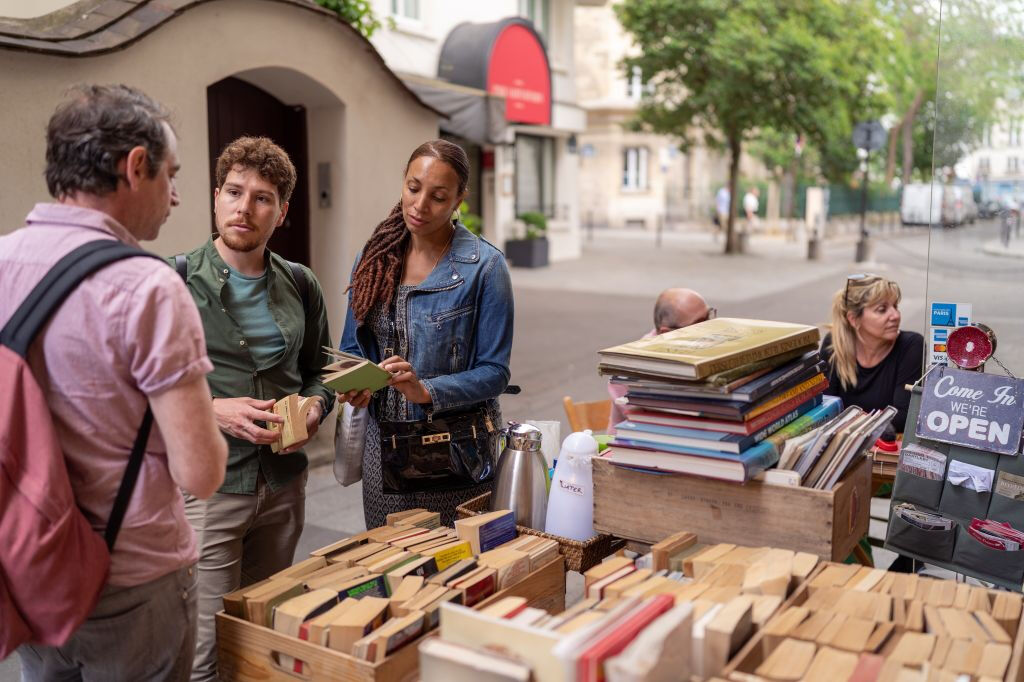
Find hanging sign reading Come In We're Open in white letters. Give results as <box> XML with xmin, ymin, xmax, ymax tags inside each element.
<box><xmin>918</xmin><ymin>367</ymin><xmax>1024</xmax><ymax>455</ymax></box>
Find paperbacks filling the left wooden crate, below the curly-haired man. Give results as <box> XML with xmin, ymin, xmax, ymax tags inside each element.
<box><xmin>218</xmin><ymin>509</ymin><xmax>558</xmax><ymax>675</ymax></box>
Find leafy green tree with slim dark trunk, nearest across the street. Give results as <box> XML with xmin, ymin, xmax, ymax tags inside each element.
<box><xmin>615</xmin><ymin>0</ymin><xmax>895</xmax><ymax>253</ymax></box>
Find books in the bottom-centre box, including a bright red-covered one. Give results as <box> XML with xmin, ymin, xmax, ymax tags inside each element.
<box><xmin>420</xmin><ymin>544</ymin><xmax>818</xmax><ymax>682</ymax></box>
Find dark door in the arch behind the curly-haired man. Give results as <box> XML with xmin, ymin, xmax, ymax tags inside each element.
<box><xmin>206</xmin><ymin>78</ymin><xmax>309</xmax><ymax>265</ymax></box>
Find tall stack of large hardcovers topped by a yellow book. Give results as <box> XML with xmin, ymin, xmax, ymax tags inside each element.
<box><xmin>598</xmin><ymin>317</ymin><xmax>841</xmax><ymax>481</ymax></box>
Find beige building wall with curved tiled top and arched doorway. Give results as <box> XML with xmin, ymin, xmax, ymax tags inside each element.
<box><xmin>0</xmin><ymin>0</ymin><xmax>440</xmax><ymax>335</ymax></box>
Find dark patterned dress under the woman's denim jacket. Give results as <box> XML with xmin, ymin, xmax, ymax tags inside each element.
<box><xmin>362</xmin><ymin>285</ymin><xmax>502</xmax><ymax>528</ymax></box>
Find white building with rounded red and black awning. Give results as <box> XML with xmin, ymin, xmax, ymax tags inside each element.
<box><xmin>372</xmin><ymin>0</ymin><xmax>602</xmax><ymax>261</ymax></box>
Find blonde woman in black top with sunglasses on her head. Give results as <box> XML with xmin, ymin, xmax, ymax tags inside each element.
<box><xmin>821</xmin><ymin>273</ymin><xmax>925</xmax><ymax>433</ymax></box>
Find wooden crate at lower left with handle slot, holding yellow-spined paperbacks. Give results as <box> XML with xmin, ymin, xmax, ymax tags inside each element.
<box><xmin>217</xmin><ymin>557</ymin><xmax>565</xmax><ymax>682</ymax></box>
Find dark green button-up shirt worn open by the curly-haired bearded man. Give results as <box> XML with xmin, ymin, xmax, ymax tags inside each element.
<box><xmin>169</xmin><ymin>239</ymin><xmax>334</xmax><ymax>495</ymax></box>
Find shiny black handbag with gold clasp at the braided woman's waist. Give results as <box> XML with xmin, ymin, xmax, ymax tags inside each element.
<box><xmin>380</xmin><ymin>408</ymin><xmax>498</xmax><ymax>494</ymax></box>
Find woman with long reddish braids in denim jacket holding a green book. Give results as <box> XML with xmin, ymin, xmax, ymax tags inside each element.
<box><xmin>338</xmin><ymin>139</ymin><xmax>513</xmax><ymax>528</ymax></box>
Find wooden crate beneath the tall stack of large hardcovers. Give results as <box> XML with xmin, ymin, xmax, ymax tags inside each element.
<box><xmin>594</xmin><ymin>450</ymin><xmax>871</xmax><ymax>561</ymax></box>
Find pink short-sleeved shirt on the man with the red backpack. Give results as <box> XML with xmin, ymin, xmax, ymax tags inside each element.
<box><xmin>0</xmin><ymin>204</ymin><xmax>213</xmax><ymax>586</ymax></box>
